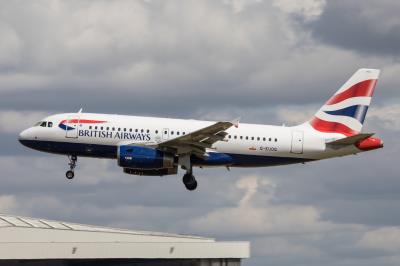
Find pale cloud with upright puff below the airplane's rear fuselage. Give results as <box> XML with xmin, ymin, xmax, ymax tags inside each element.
<box><xmin>191</xmin><ymin>177</ymin><xmax>358</xmax><ymax>236</ymax></box>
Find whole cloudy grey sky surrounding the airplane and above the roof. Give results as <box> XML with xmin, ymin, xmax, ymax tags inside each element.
<box><xmin>0</xmin><ymin>0</ymin><xmax>400</xmax><ymax>266</ymax></box>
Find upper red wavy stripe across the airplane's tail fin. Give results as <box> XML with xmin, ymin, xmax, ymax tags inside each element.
<box><xmin>326</xmin><ymin>79</ymin><xmax>378</xmax><ymax>105</ymax></box>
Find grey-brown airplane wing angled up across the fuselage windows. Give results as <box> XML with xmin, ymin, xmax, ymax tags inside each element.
<box><xmin>157</xmin><ymin>119</ymin><xmax>239</xmax><ymax>157</ymax></box>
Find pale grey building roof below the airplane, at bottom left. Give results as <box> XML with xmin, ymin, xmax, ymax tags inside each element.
<box><xmin>0</xmin><ymin>214</ymin><xmax>250</xmax><ymax>259</ymax></box>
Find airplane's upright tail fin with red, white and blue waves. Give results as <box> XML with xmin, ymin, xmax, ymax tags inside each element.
<box><xmin>308</xmin><ymin>68</ymin><xmax>380</xmax><ymax>136</ymax></box>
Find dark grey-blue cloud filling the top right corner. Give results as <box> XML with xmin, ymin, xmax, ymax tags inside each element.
<box><xmin>310</xmin><ymin>0</ymin><xmax>400</xmax><ymax>56</ymax></box>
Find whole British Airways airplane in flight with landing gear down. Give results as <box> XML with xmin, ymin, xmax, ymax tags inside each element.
<box><xmin>19</xmin><ymin>69</ymin><xmax>383</xmax><ymax>191</ymax></box>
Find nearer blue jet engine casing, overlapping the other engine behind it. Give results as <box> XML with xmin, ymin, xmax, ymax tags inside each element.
<box><xmin>118</xmin><ymin>145</ymin><xmax>175</xmax><ymax>170</ymax></box>
